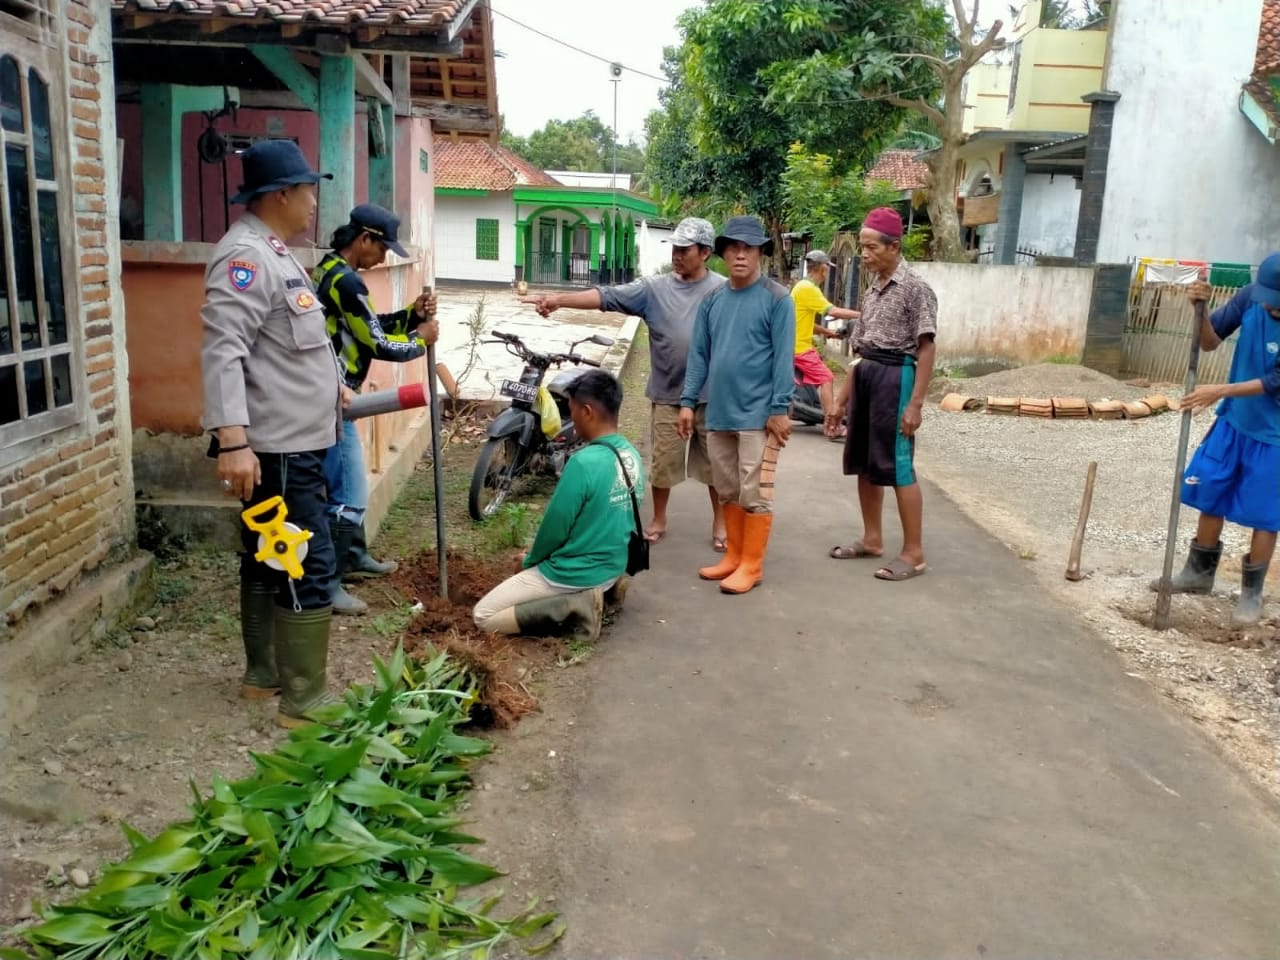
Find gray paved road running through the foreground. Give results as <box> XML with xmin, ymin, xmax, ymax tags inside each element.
<box><xmin>557</xmin><ymin>435</ymin><xmax>1280</xmax><ymax>960</ymax></box>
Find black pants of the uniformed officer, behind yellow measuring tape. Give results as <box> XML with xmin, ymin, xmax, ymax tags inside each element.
<box><xmin>241</xmin><ymin>451</ymin><xmax>337</xmax><ymax>611</ymax></box>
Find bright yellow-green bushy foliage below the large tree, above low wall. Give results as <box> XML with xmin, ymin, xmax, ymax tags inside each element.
<box><xmin>782</xmin><ymin>143</ymin><xmax>897</xmax><ymax>250</ymax></box>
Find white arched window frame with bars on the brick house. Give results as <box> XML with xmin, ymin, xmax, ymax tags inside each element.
<box><xmin>0</xmin><ymin>0</ymin><xmax>83</xmax><ymax>466</ymax></box>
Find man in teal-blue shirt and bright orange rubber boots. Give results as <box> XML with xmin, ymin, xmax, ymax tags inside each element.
<box><xmin>677</xmin><ymin>216</ymin><xmax>796</xmax><ymax>594</ymax></box>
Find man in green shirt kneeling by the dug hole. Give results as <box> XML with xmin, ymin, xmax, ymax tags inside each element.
<box><xmin>475</xmin><ymin>370</ymin><xmax>644</xmax><ymax>641</ymax></box>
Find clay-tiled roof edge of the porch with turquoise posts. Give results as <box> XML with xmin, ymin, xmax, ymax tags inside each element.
<box><xmin>111</xmin><ymin>0</ymin><xmax>470</xmax><ymax>31</ymax></box>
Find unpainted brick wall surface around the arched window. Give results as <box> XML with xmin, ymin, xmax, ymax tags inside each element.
<box><xmin>0</xmin><ymin>0</ymin><xmax>134</xmax><ymax>632</ymax></box>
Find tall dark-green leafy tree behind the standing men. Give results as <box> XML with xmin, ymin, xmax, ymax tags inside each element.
<box><xmin>649</xmin><ymin>0</ymin><xmax>946</xmax><ymax>266</ymax></box>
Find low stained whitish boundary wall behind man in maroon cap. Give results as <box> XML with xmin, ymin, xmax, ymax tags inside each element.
<box><xmin>910</xmin><ymin>262</ymin><xmax>1093</xmax><ymax>366</ymax></box>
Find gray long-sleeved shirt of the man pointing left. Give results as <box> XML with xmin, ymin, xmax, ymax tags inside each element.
<box><xmin>595</xmin><ymin>270</ymin><xmax>724</xmax><ymax>406</ymax></box>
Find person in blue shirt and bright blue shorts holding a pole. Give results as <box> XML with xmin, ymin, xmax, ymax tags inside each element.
<box><xmin>1172</xmin><ymin>253</ymin><xmax>1280</xmax><ymax>625</ymax></box>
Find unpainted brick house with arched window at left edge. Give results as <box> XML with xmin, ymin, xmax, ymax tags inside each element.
<box><xmin>0</xmin><ymin>0</ymin><xmax>145</xmax><ymax>654</ymax></box>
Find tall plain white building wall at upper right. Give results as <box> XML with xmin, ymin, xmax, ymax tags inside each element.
<box><xmin>1097</xmin><ymin>0</ymin><xmax>1280</xmax><ymax>264</ymax></box>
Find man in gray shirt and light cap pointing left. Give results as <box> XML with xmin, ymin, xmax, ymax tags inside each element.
<box><xmin>524</xmin><ymin>216</ymin><xmax>726</xmax><ymax>552</ymax></box>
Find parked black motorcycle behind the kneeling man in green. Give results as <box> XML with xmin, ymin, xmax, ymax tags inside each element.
<box><xmin>467</xmin><ymin>332</ymin><xmax>613</xmax><ymax>521</ymax></box>
